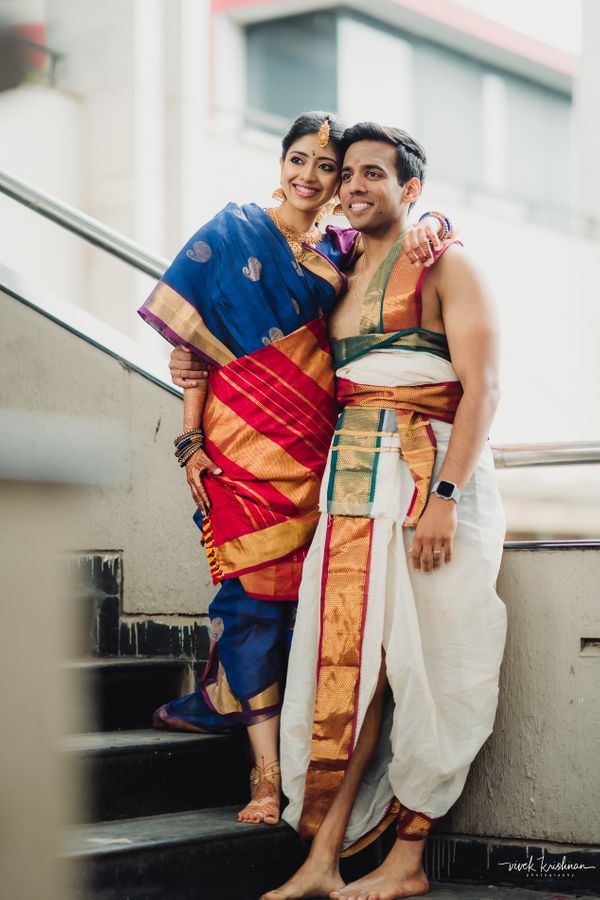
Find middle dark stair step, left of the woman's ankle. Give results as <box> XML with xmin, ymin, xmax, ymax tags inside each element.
<box><xmin>62</xmin><ymin>729</ymin><xmax>249</xmax><ymax>822</ymax></box>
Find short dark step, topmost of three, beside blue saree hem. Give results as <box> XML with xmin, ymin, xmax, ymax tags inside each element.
<box><xmin>66</xmin><ymin>657</ymin><xmax>190</xmax><ymax>731</ymax></box>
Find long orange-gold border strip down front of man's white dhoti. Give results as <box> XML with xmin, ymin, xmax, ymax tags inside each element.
<box><xmin>300</xmin><ymin>516</ymin><xmax>373</xmax><ymax>840</ymax></box>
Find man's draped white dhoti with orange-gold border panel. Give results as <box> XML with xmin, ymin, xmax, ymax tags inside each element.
<box><xmin>281</xmin><ymin>347</ymin><xmax>506</xmax><ymax>854</ymax></box>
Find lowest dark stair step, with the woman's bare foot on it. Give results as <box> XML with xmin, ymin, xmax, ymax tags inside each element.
<box><xmin>67</xmin><ymin>807</ymin><xmax>303</xmax><ymax>900</ymax></box>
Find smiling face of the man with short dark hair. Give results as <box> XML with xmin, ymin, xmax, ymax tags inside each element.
<box><xmin>339</xmin><ymin>141</ymin><xmax>418</xmax><ymax>234</ymax></box>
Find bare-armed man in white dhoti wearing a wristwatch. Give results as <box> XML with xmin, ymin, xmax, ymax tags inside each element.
<box><xmin>263</xmin><ymin>123</ymin><xmax>506</xmax><ymax>900</ymax></box>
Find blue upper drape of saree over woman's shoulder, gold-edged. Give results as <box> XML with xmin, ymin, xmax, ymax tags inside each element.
<box><xmin>138</xmin><ymin>203</ymin><xmax>345</xmax><ymax>366</ymax></box>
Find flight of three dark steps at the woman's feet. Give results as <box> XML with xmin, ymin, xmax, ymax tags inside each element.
<box><xmin>63</xmin><ymin>659</ymin><xmax>301</xmax><ymax>900</ymax></box>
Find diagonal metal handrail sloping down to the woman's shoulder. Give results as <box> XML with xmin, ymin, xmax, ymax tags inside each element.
<box><xmin>0</xmin><ymin>170</ymin><xmax>169</xmax><ymax>278</ymax></box>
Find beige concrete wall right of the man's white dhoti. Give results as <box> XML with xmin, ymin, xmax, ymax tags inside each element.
<box><xmin>444</xmin><ymin>545</ymin><xmax>600</xmax><ymax>844</ymax></box>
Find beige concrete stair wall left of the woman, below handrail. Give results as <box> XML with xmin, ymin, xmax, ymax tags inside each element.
<box><xmin>0</xmin><ymin>293</ymin><xmax>212</xmax><ymax>616</ymax></box>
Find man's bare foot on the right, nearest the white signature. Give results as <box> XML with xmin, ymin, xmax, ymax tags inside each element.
<box><xmin>329</xmin><ymin>841</ymin><xmax>429</xmax><ymax>900</ymax></box>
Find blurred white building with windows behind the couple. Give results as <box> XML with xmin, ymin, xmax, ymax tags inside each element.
<box><xmin>0</xmin><ymin>0</ymin><xmax>600</xmax><ymax>536</ymax></box>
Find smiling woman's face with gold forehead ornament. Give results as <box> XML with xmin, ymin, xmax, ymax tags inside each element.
<box><xmin>281</xmin><ymin>134</ymin><xmax>340</xmax><ymax>212</ymax></box>
